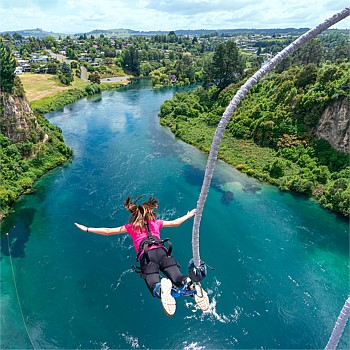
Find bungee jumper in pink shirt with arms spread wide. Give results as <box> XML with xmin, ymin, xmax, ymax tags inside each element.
<box><xmin>75</xmin><ymin>196</ymin><xmax>209</xmax><ymax>316</ymax></box>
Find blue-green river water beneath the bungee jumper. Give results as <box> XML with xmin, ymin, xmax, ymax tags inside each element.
<box><xmin>0</xmin><ymin>82</ymin><xmax>350</xmax><ymax>349</ymax></box>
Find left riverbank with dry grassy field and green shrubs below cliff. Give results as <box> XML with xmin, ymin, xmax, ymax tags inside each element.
<box><xmin>0</xmin><ymin>74</ymin><xmax>130</xmax><ymax>220</ymax></box>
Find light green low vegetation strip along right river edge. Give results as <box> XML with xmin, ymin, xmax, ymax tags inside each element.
<box><xmin>160</xmin><ymin>112</ymin><xmax>349</xmax><ymax>217</ymax></box>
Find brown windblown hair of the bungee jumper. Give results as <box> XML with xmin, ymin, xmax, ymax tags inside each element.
<box><xmin>124</xmin><ymin>195</ymin><xmax>158</xmax><ymax>232</ymax></box>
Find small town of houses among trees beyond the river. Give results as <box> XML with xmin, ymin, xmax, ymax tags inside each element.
<box><xmin>0</xmin><ymin>28</ymin><xmax>306</xmax><ymax>85</ymax></box>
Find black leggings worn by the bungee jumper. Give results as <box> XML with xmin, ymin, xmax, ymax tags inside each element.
<box><xmin>140</xmin><ymin>248</ymin><xmax>187</xmax><ymax>295</ymax></box>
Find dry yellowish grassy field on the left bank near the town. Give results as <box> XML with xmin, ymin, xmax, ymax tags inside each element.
<box><xmin>19</xmin><ymin>73</ymin><xmax>90</xmax><ymax>102</ymax></box>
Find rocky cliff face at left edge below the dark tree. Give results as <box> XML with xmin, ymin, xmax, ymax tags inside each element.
<box><xmin>0</xmin><ymin>93</ymin><xmax>43</xmax><ymax>143</ymax></box>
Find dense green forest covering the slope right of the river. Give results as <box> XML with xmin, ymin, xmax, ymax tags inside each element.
<box><xmin>159</xmin><ymin>39</ymin><xmax>350</xmax><ymax>216</ymax></box>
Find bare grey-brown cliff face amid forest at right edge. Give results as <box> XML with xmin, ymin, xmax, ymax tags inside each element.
<box><xmin>316</xmin><ymin>98</ymin><xmax>350</xmax><ymax>153</ymax></box>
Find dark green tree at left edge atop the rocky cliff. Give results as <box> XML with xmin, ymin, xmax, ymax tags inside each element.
<box><xmin>0</xmin><ymin>42</ymin><xmax>16</xmax><ymax>92</ymax></box>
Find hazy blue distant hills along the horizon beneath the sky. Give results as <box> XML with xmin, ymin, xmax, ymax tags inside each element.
<box><xmin>0</xmin><ymin>28</ymin><xmax>350</xmax><ymax>39</ymax></box>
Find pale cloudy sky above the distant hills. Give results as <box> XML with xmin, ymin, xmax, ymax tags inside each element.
<box><xmin>0</xmin><ymin>0</ymin><xmax>350</xmax><ymax>34</ymax></box>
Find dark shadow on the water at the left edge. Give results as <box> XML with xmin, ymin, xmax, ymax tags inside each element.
<box><xmin>0</xmin><ymin>208</ymin><xmax>36</xmax><ymax>258</ymax></box>
